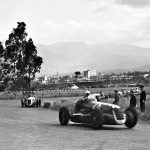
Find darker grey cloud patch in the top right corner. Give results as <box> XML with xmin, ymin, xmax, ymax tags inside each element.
<box><xmin>115</xmin><ymin>0</ymin><xmax>150</xmax><ymax>8</ymax></box>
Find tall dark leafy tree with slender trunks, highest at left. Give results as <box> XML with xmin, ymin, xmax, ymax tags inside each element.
<box><xmin>2</xmin><ymin>22</ymin><xmax>43</xmax><ymax>94</ymax></box>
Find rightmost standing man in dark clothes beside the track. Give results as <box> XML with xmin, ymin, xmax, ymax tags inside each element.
<box><xmin>140</xmin><ymin>85</ymin><xmax>146</xmax><ymax>112</ymax></box>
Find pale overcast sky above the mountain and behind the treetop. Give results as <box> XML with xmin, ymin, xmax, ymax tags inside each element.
<box><xmin>0</xmin><ymin>0</ymin><xmax>150</xmax><ymax>47</ymax></box>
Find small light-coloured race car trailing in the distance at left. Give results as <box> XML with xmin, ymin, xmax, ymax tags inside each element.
<box><xmin>21</xmin><ymin>96</ymin><xmax>41</xmax><ymax>107</ymax></box>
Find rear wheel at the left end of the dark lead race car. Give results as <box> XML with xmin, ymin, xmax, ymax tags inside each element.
<box><xmin>59</xmin><ymin>107</ymin><xmax>70</xmax><ymax>125</ymax></box>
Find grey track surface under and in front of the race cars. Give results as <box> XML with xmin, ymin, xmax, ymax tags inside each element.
<box><xmin>0</xmin><ymin>100</ymin><xmax>150</xmax><ymax>150</ymax></box>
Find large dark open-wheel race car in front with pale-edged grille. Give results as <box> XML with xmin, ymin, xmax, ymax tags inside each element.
<box><xmin>59</xmin><ymin>94</ymin><xmax>138</xmax><ymax>129</ymax></box>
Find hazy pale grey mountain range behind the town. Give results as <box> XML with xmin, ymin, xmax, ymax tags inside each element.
<box><xmin>37</xmin><ymin>42</ymin><xmax>150</xmax><ymax>74</ymax></box>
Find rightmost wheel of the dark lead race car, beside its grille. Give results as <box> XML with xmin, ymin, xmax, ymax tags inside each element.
<box><xmin>125</xmin><ymin>107</ymin><xmax>138</xmax><ymax>128</ymax></box>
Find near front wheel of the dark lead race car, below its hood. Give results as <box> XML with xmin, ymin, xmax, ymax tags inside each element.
<box><xmin>92</xmin><ymin>109</ymin><xmax>104</xmax><ymax>129</ymax></box>
